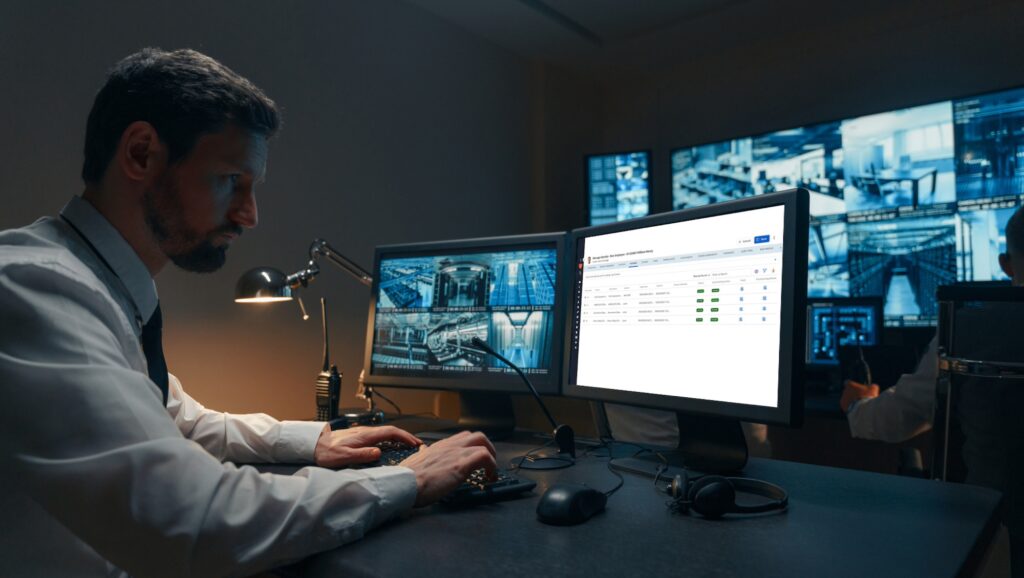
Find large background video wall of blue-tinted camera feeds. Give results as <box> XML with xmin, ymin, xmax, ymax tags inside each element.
<box><xmin>672</xmin><ymin>83</ymin><xmax>1024</xmax><ymax>326</ymax></box>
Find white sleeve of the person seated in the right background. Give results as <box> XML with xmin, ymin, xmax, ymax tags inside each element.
<box><xmin>846</xmin><ymin>336</ymin><xmax>939</xmax><ymax>443</ymax></box>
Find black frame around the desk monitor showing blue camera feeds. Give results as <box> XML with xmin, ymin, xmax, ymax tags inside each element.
<box><xmin>362</xmin><ymin>233</ymin><xmax>567</xmax><ymax>395</ymax></box>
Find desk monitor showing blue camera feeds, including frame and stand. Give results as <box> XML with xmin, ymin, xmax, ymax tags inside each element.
<box><xmin>364</xmin><ymin>233</ymin><xmax>566</xmax><ymax>435</ymax></box>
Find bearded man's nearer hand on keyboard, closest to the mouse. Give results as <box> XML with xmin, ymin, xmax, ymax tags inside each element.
<box><xmin>398</xmin><ymin>431</ymin><xmax>498</xmax><ymax>507</ymax></box>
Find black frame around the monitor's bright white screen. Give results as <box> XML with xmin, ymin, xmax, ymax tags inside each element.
<box><xmin>562</xmin><ymin>189</ymin><xmax>809</xmax><ymax>425</ymax></box>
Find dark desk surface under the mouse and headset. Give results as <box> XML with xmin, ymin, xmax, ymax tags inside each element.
<box><xmin>292</xmin><ymin>442</ymin><xmax>999</xmax><ymax>578</ymax></box>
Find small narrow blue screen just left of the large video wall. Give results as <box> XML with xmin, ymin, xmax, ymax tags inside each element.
<box><xmin>587</xmin><ymin>152</ymin><xmax>649</xmax><ymax>224</ymax></box>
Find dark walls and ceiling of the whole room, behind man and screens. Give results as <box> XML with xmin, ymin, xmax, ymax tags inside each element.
<box><xmin>0</xmin><ymin>0</ymin><xmax>1024</xmax><ymax>418</ymax></box>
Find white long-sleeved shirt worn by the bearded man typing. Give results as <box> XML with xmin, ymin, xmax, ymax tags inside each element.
<box><xmin>0</xmin><ymin>198</ymin><xmax>416</xmax><ymax>576</ymax></box>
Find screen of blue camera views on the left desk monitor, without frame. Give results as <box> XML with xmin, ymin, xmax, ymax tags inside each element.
<box><xmin>372</xmin><ymin>249</ymin><xmax>557</xmax><ymax>377</ymax></box>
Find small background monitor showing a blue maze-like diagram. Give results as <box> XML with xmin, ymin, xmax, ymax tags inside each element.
<box><xmin>805</xmin><ymin>297</ymin><xmax>882</xmax><ymax>366</ymax></box>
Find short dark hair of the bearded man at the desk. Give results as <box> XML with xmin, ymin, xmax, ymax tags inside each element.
<box><xmin>82</xmin><ymin>48</ymin><xmax>281</xmax><ymax>184</ymax></box>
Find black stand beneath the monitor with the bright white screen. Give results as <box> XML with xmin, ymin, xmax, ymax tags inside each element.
<box><xmin>611</xmin><ymin>412</ymin><xmax>748</xmax><ymax>479</ymax></box>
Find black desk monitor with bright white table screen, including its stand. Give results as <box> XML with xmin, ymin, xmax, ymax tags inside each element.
<box><xmin>563</xmin><ymin>190</ymin><xmax>808</xmax><ymax>470</ymax></box>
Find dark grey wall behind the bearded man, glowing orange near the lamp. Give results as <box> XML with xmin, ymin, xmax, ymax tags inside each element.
<box><xmin>0</xmin><ymin>0</ymin><xmax>535</xmax><ymax>418</ymax></box>
